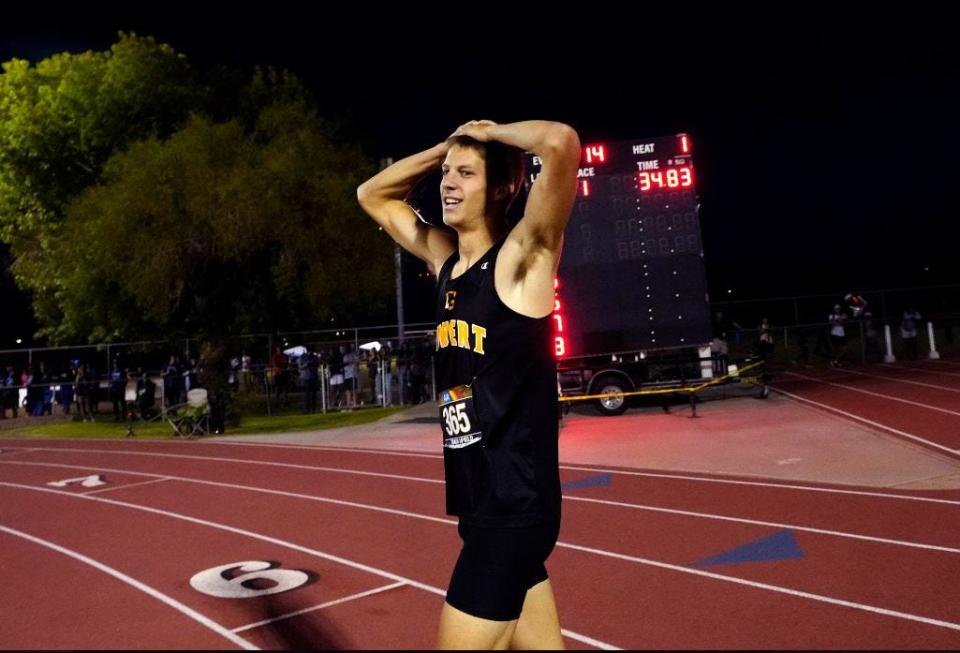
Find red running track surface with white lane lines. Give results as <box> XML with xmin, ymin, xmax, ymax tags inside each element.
<box><xmin>0</xmin><ymin>362</ymin><xmax>960</xmax><ymax>649</ymax></box>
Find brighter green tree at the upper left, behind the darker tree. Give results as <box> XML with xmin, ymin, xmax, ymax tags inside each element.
<box><xmin>0</xmin><ymin>34</ymin><xmax>202</xmax><ymax>246</ymax></box>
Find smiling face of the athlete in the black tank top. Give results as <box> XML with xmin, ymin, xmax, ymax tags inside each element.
<box><xmin>440</xmin><ymin>145</ymin><xmax>487</xmax><ymax>228</ymax></box>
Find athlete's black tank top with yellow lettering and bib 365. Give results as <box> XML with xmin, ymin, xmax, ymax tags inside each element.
<box><xmin>436</xmin><ymin>239</ymin><xmax>560</xmax><ymax>526</ymax></box>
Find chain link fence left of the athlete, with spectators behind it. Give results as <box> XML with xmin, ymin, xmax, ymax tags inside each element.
<box><xmin>0</xmin><ymin>324</ymin><xmax>436</xmax><ymax>421</ymax></box>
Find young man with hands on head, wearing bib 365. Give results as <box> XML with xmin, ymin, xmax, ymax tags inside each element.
<box><xmin>357</xmin><ymin>120</ymin><xmax>580</xmax><ymax>649</ymax></box>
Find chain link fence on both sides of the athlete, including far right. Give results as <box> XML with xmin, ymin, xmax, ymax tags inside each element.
<box><xmin>0</xmin><ymin>285</ymin><xmax>960</xmax><ymax>420</ymax></box>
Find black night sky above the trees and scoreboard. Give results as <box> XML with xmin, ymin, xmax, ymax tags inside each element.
<box><xmin>0</xmin><ymin>10</ymin><xmax>960</xmax><ymax>341</ymax></box>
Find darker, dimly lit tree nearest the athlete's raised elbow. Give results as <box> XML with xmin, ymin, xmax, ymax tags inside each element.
<box><xmin>47</xmin><ymin>102</ymin><xmax>392</xmax><ymax>341</ymax></box>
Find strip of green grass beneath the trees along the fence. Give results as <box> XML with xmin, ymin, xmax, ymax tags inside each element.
<box><xmin>2</xmin><ymin>406</ymin><xmax>405</xmax><ymax>439</ymax></box>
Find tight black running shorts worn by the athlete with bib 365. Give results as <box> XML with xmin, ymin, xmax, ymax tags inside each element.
<box><xmin>447</xmin><ymin>521</ymin><xmax>560</xmax><ymax>621</ymax></box>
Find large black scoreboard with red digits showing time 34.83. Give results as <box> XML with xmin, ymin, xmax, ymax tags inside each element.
<box><xmin>527</xmin><ymin>134</ymin><xmax>710</xmax><ymax>358</ymax></box>
